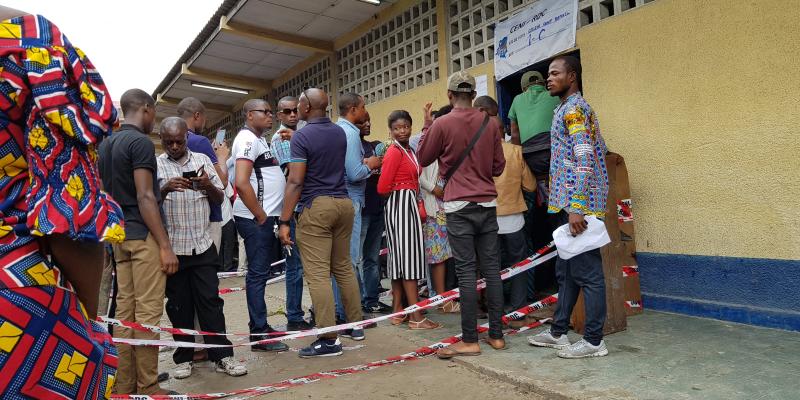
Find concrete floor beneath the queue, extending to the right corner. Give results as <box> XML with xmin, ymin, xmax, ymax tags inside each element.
<box><xmin>153</xmin><ymin>278</ymin><xmax>800</xmax><ymax>400</ymax></box>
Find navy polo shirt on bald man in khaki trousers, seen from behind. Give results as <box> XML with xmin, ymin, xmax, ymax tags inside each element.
<box><xmin>291</xmin><ymin>117</ymin><xmax>347</xmax><ymax>211</ymax></box>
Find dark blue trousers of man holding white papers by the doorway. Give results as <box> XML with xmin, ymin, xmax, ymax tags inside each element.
<box><xmin>550</xmin><ymin>211</ymin><xmax>606</xmax><ymax>346</ymax></box>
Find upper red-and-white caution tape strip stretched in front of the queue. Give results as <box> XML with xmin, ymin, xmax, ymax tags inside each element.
<box><xmin>106</xmin><ymin>245</ymin><xmax>558</xmax><ymax>348</ymax></box>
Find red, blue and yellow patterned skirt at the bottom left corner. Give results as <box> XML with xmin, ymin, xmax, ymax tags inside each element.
<box><xmin>0</xmin><ymin>286</ymin><xmax>117</xmax><ymax>399</ymax></box>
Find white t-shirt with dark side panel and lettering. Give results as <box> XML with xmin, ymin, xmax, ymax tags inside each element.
<box><xmin>231</xmin><ymin>128</ymin><xmax>286</xmax><ymax>218</ymax></box>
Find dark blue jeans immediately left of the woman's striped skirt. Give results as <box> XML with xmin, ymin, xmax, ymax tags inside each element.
<box><xmin>361</xmin><ymin>213</ymin><xmax>386</xmax><ymax>307</ymax></box>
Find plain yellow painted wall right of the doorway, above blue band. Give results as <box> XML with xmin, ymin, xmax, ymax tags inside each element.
<box><xmin>577</xmin><ymin>0</ymin><xmax>800</xmax><ymax>259</ymax></box>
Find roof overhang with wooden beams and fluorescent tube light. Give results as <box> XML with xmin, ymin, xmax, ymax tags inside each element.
<box><xmin>153</xmin><ymin>0</ymin><xmax>396</xmax><ymax>123</ymax></box>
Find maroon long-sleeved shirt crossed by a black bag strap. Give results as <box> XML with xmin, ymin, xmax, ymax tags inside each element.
<box><xmin>417</xmin><ymin>108</ymin><xmax>506</xmax><ymax>203</ymax></box>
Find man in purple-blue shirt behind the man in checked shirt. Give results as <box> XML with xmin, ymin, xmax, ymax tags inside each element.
<box><xmin>177</xmin><ymin>97</ymin><xmax>230</xmax><ymax>251</ymax></box>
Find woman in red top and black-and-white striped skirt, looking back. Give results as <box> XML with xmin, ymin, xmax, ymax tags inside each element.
<box><xmin>378</xmin><ymin>110</ymin><xmax>441</xmax><ymax>330</ymax></box>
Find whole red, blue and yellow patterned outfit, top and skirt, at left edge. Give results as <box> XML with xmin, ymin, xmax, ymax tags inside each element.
<box><xmin>0</xmin><ymin>15</ymin><xmax>125</xmax><ymax>399</ymax></box>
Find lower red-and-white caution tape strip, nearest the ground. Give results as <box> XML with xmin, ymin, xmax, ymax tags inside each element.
<box><xmin>111</xmin><ymin>294</ymin><xmax>558</xmax><ymax>400</ymax></box>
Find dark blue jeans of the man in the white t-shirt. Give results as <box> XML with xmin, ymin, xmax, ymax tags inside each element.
<box><xmin>234</xmin><ymin>217</ymin><xmax>277</xmax><ymax>333</ymax></box>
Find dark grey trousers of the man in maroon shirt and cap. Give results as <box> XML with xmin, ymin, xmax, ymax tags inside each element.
<box><xmin>447</xmin><ymin>203</ymin><xmax>503</xmax><ymax>343</ymax></box>
